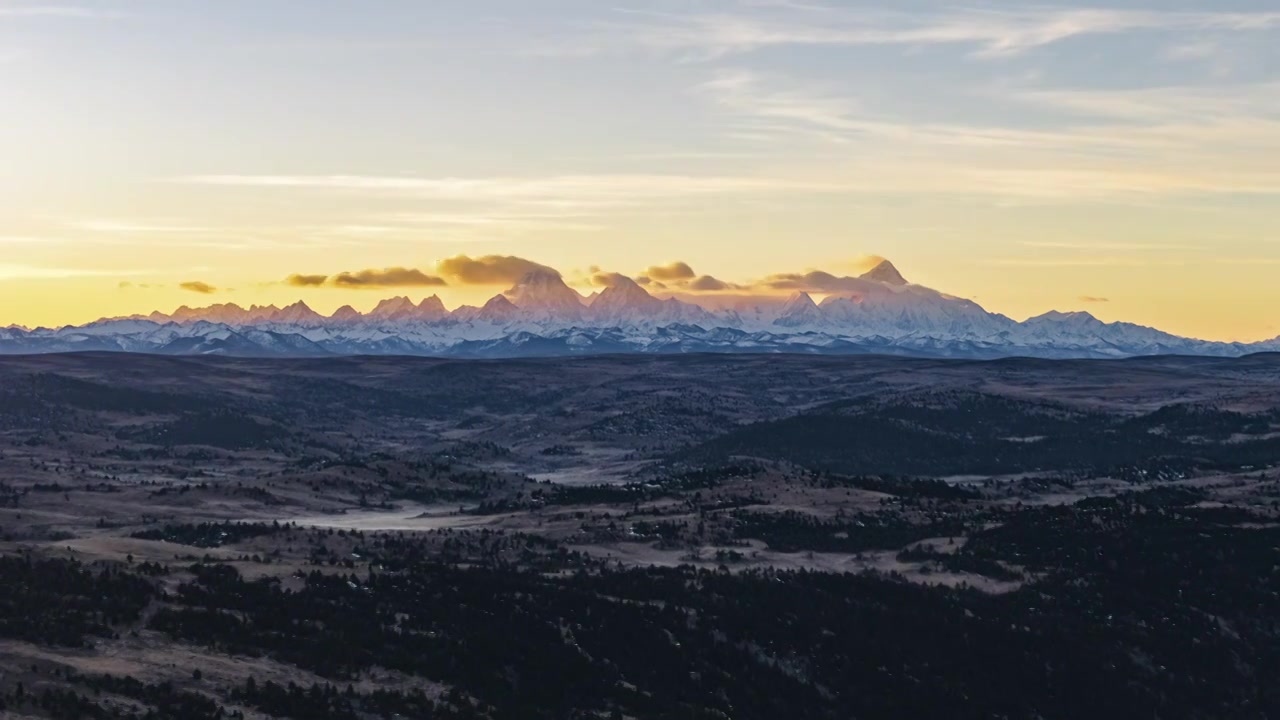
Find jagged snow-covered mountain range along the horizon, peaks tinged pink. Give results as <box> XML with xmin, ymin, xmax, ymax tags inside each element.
<box><xmin>0</xmin><ymin>261</ymin><xmax>1280</xmax><ymax>359</ymax></box>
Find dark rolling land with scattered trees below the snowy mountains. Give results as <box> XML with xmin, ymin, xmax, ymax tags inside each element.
<box><xmin>0</xmin><ymin>354</ymin><xmax>1280</xmax><ymax>719</ymax></box>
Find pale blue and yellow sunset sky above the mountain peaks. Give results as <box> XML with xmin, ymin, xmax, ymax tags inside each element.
<box><xmin>0</xmin><ymin>0</ymin><xmax>1280</xmax><ymax>341</ymax></box>
